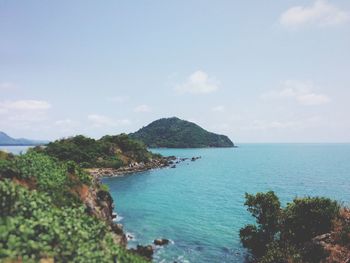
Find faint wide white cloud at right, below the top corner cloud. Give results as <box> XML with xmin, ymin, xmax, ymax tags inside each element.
<box><xmin>261</xmin><ymin>80</ymin><xmax>331</xmax><ymax>106</ymax></box>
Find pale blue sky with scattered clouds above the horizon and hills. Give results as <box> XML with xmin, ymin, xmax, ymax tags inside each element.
<box><xmin>0</xmin><ymin>0</ymin><xmax>350</xmax><ymax>143</ymax></box>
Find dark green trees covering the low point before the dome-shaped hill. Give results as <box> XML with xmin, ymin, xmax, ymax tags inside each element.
<box><xmin>34</xmin><ymin>134</ymin><xmax>155</xmax><ymax>168</ymax></box>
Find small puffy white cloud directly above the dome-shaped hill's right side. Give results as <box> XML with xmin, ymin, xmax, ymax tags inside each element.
<box><xmin>175</xmin><ymin>70</ymin><xmax>219</xmax><ymax>94</ymax></box>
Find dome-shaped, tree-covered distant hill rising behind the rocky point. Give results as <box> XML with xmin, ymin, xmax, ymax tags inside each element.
<box><xmin>130</xmin><ymin>117</ymin><xmax>234</xmax><ymax>148</ymax></box>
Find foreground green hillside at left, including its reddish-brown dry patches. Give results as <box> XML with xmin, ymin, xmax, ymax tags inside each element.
<box><xmin>0</xmin><ymin>151</ymin><xmax>144</xmax><ymax>262</ymax></box>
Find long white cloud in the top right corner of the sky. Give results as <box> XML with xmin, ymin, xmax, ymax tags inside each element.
<box><xmin>280</xmin><ymin>0</ymin><xmax>350</xmax><ymax>28</ymax></box>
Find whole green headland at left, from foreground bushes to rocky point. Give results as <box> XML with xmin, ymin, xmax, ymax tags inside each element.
<box><xmin>0</xmin><ymin>134</ymin><xmax>175</xmax><ymax>262</ymax></box>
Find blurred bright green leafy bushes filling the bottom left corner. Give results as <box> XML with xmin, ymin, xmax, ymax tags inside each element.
<box><xmin>0</xmin><ymin>179</ymin><xmax>144</xmax><ymax>262</ymax></box>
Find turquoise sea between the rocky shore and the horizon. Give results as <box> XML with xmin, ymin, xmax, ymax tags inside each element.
<box><xmin>103</xmin><ymin>144</ymin><xmax>350</xmax><ymax>263</ymax></box>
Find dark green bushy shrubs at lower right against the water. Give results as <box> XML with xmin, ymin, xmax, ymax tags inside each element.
<box><xmin>240</xmin><ymin>191</ymin><xmax>340</xmax><ymax>263</ymax></box>
